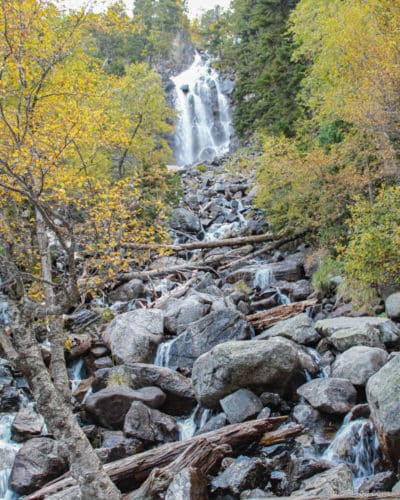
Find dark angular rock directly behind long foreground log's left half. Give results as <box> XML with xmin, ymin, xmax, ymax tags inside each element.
<box><xmin>124</xmin><ymin>401</ymin><xmax>179</xmax><ymax>443</ymax></box>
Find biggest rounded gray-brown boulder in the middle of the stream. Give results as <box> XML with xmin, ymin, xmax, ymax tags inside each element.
<box><xmin>192</xmin><ymin>337</ymin><xmax>317</xmax><ymax>408</ymax></box>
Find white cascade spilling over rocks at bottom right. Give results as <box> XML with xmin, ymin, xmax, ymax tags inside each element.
<box><xmin>322</xmin><ymin>417</ymin><xmax>378</xmax><ymax>489</ymax></box>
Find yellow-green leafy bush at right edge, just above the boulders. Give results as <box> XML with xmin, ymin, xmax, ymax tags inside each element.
<box><xmin>342</xmin><ymin>186</ymin><xmax>400</xmax><ymax>290</ymax></box>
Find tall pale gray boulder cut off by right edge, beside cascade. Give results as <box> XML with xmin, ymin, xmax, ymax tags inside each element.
<box><xmin>366</xmin><ymin>356</ymin><xmax>400</xmax><ymax>464</ymax></box>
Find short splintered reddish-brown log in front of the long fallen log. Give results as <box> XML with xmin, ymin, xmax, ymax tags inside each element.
<box><xmin>128</xmin><ymin>439</ymin><xmax>232</xmax><ymax>500</ymax></box>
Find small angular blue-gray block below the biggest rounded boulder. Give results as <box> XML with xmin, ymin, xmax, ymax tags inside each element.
<box><xmin>219</xmin><ymin>389</ymin><xmax>263</xmax><ymax>424</ymax></box>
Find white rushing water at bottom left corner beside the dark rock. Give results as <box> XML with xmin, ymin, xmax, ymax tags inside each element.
<box><xmin>0</xmin><ymin>413</ymin><xmax>21</xmax><ymax>500</ymax></box>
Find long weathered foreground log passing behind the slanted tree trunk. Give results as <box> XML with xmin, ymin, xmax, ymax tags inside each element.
<box><xmin>25</xmin><ymin>416</ymin><xmax>304</xmax><ymax>500</ymax></box>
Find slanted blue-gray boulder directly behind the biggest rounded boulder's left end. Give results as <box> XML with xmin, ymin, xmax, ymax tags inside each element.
<box><xmin>169</xmin><ymin>308</ymin><xmax>247</xmax><ymax>368</ymax></box>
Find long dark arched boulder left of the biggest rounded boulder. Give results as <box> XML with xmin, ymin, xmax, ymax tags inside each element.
<box><xmin>126</xmin><ymin>363</ymin><xmax>196</xmax><ymax>415</ymax></box>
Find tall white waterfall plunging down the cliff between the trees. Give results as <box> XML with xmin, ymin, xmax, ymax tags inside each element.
<box><xmin>171</xmin><ymin>53</ymin><xmax>232</xmax><ymax>165</ymax></box>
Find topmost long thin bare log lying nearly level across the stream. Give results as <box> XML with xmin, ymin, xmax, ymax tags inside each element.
<box><xmin>121</xmin><ymin>233</ymin><xmax>274</xmax><ymax>252</ymax></box>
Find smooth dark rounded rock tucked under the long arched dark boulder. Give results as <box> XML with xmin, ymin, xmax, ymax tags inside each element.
<box><xmin>85</xmin><ymin>386</ymin><xmax>166</xmax><ymax>429</ymax></box>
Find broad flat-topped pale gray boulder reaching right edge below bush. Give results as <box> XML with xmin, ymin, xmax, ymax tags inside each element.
<box><xmin>315</xmin><ymin>316</ymin><xmax>400</xmax><ymax>348</ymax></box>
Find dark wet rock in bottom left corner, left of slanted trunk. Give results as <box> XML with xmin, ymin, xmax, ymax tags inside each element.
<box><xmin>9</xmin><ymin>438</ymin><xmax>68</xmax><ymax>495</ymax></box>
